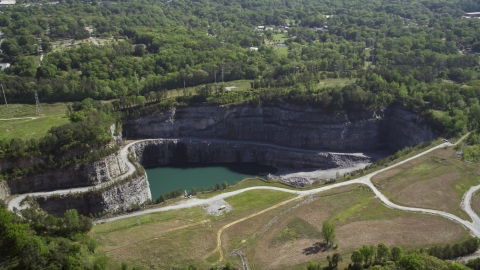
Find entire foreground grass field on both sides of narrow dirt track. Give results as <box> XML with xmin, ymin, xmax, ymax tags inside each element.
<box><xmin>91</xmin><ymin>181</ymin><xmax>468</xmax><ymax>269</ymax></box>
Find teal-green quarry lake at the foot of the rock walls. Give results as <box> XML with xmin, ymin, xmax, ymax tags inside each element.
<box><xmin>146</xmin><ymin>163</ymin><xmax>277</xmax><ymax>200</ymax></box>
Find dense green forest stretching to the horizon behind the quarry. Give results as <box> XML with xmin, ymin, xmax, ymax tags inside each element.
<box><xmin>0</xmin><ymin>0</ymin><xmax>480</xmax><ymax>139</ymax></box>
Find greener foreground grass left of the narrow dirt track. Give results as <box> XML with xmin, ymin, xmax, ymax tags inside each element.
<box><xmin>91</xmin><ymin>191</ymin><xmax>294</xmax><ymax>269</ymax></box>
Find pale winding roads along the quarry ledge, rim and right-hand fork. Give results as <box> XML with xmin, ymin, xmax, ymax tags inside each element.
<box><xmin>8</xmin><ymin>136</ymin><xmax>480</xmax><ymax>237</ymax></box>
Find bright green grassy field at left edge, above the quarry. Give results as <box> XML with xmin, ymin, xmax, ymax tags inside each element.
<box><xmin>0</xmin><ymin>103</ymin><xmax>69</xmax><ymax>139</ymax></box>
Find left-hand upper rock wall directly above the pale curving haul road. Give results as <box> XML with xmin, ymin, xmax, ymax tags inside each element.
<box><xmin>5</xmin><ymin>153</ymin><xmax>128</xmax><ymax>196</ymax></box>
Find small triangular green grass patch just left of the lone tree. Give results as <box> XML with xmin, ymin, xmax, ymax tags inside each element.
<box><xmin>270</xmin><ymin>217</ymin><xmax>321</xmax><ymax>246</ymax></box>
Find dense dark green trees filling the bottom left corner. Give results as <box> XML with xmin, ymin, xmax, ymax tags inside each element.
<box><xmin>0</xmin><ymin>201</ymin><xmax>114</xmax><ymax>269</ymax></box>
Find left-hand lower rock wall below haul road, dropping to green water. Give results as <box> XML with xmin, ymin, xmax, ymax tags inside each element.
<box><xmin>35</xmin><ymin>174</ymin><xmax>152</xmax><ymax>217</ymax></box>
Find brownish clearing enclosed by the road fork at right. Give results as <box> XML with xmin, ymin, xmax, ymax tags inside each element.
<box><xmin>372</xmin><ymin>148</ymin><xmax>480</xmax><ymax>220</ymax></box>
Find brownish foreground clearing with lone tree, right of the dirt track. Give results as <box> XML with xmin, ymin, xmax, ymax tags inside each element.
<box><xmin>246</xmin><ymin>187</ymin><xmax>469</xmax><ymax>269</ymax></box>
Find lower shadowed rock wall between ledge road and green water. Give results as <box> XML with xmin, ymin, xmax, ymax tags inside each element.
<box><xmin>133</xmin><ymin>139</ymin><xmax>371</xmax><ymax>169</ymax></box>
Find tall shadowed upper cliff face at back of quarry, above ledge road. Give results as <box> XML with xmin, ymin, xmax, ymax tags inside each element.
<box><xmin>122</xmin><ymin>103</ymin><xmax>437</xmax><ymax>151</ymax></box>
